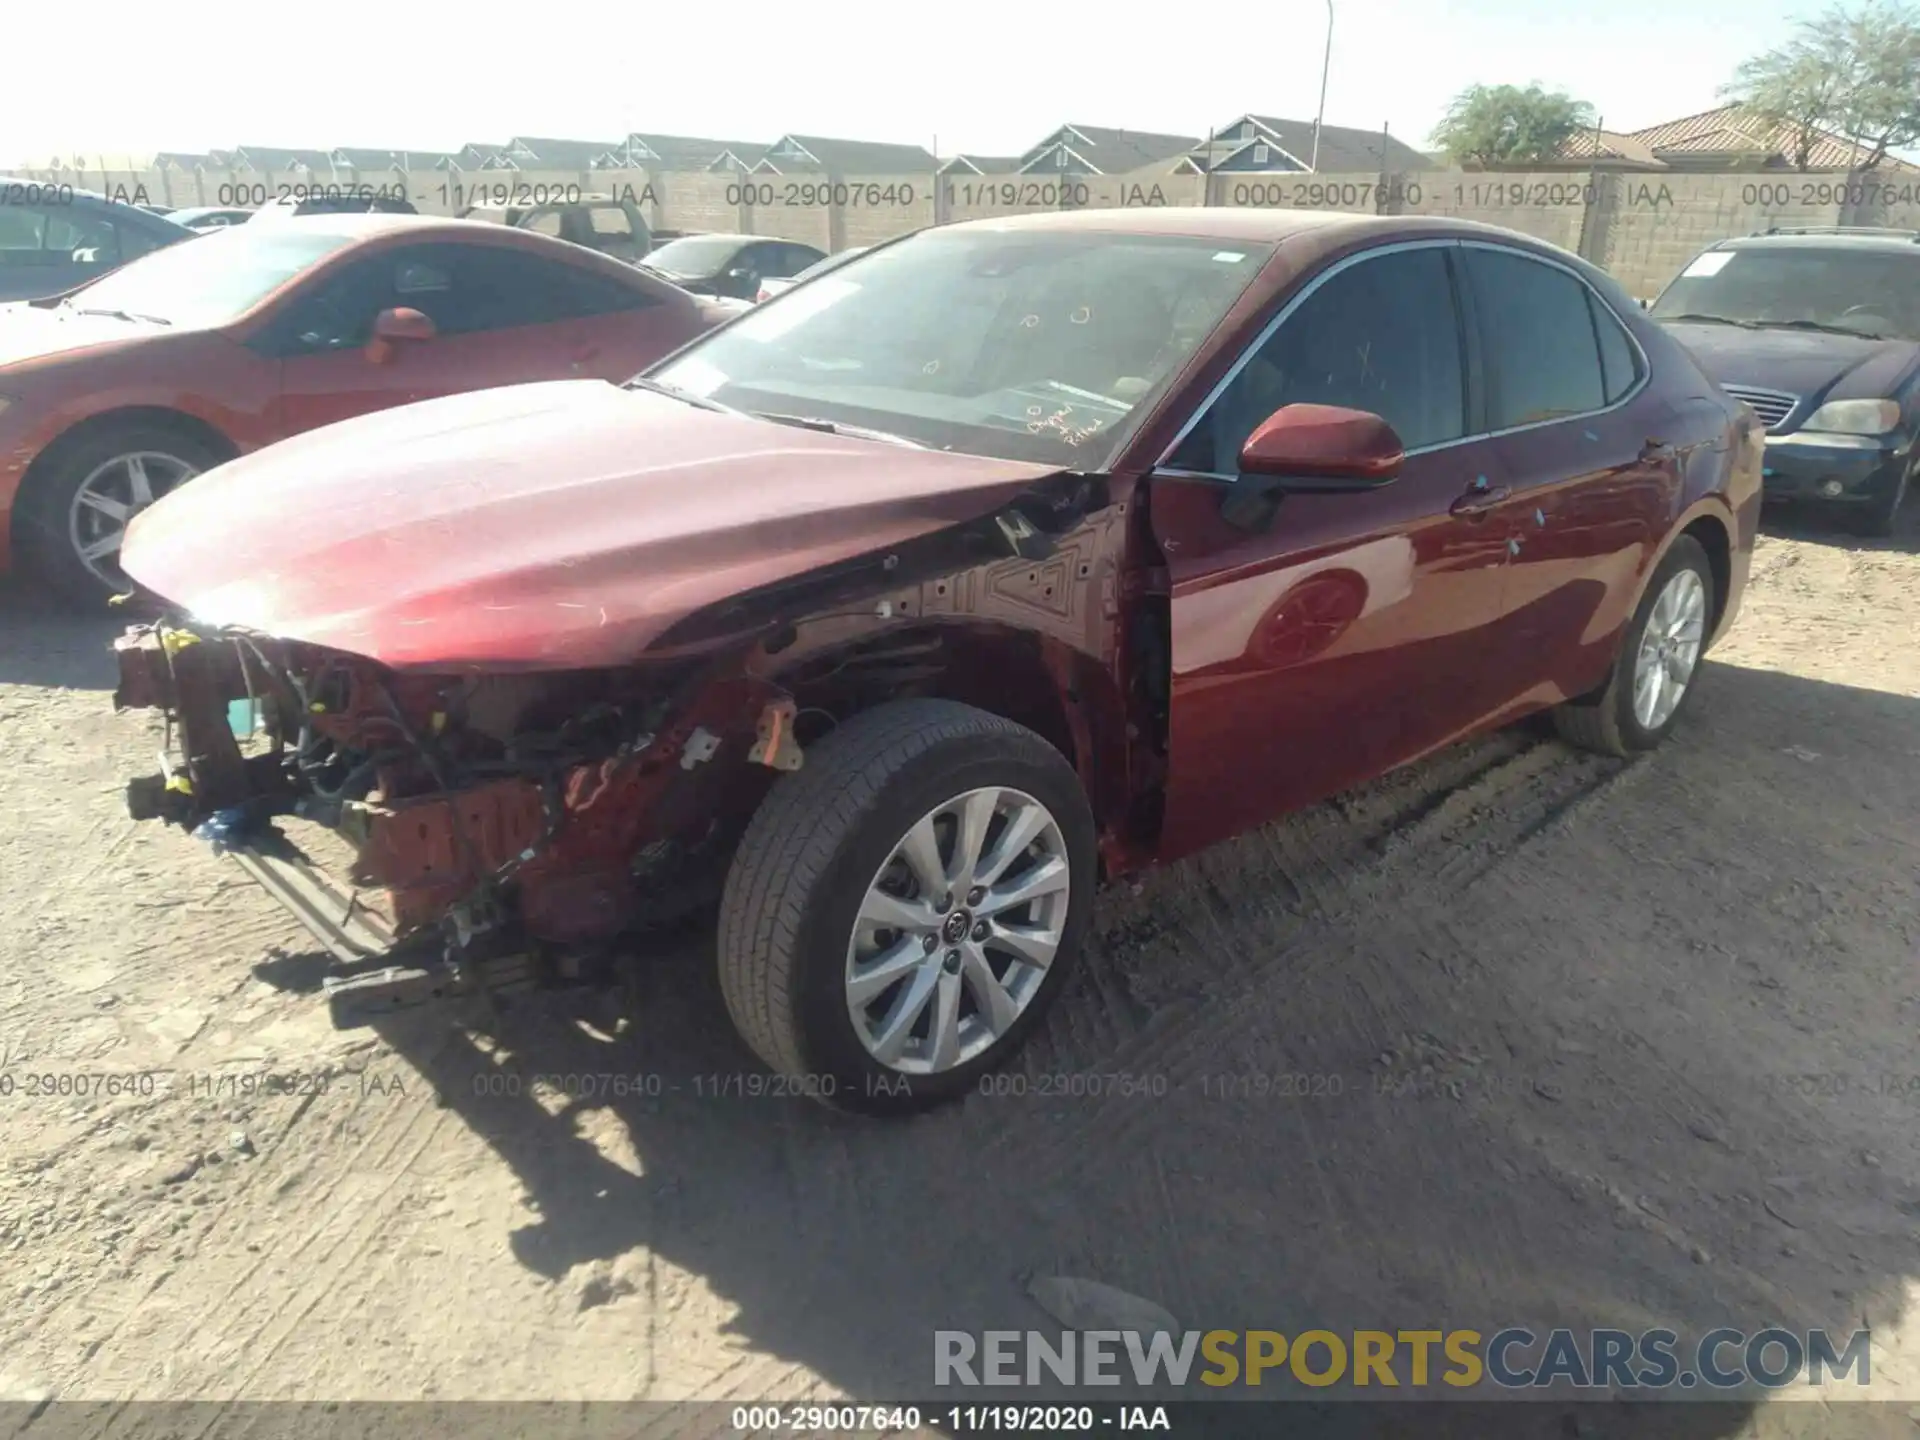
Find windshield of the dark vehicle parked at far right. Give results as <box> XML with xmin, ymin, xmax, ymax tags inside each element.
<box><xmin>1649</xmin><ymin>246</ymin><xmax>1920</xmax><ymax>340</ymax></box>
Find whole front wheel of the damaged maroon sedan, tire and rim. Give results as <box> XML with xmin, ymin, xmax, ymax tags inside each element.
<box><xmin>718</xmin><ymin>701</ymin><xmax>1094</xmax><ymax>1114</ymax></box>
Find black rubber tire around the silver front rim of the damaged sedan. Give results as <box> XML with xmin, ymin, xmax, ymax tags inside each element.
<box><xmin>718</xmin><ymin>699</ymin><xmax>1096</xmax><ymax>1116</ymax></box>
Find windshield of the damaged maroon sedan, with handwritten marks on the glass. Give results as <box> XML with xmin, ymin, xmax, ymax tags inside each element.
<box><xmin>651</xmin><ymin>230</ymin><xmax>1273</xmax><ymax>468</ymax></box>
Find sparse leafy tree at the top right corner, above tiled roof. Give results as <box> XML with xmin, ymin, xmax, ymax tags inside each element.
<box><xmin>1720</xmin><ymin>0</ymin><xmax>1920</xmax><ymax>171</ymax></box>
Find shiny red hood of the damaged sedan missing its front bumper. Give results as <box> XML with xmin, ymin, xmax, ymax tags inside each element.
<box><xmin>121</xmin><ymin>380</ymin><xmax>1056</xmax><ymax>670</ymax></box>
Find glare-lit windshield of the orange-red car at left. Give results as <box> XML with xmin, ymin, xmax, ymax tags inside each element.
<box><xmin>65</xmin><ymin>225</ymin><xmax>353</xmax><ymax>326</ymax></box>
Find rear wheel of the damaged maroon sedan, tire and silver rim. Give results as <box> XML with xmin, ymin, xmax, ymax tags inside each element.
<box><xmin>1553</xmin><ymin>536</ymin><xmax>1715</xmax><ymax>756</ymax></box>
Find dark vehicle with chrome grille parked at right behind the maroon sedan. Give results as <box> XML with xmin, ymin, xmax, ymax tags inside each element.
<box><xmin>1651</xmin><ymin>227</ymin><xmax>1920</xmax><ymax>536</ymax></box>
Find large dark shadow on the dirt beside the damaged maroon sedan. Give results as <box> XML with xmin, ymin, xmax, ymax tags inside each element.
<box><xmin>255</xmin><ymin>664</ymin><xmax>1920</xmax><ymax>1436</ymax></box>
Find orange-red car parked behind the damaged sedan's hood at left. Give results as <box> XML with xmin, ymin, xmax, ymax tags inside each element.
<box><xmin>0</xmin><ymin>215</ymin><xmax>737</xmax><ymax>601</ymax></box>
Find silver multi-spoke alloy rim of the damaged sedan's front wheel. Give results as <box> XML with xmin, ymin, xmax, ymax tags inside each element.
<box><xmin>847</xmin><ymin>787</ymin><xmax>1073</xmax><ymax>1075</ymax></box>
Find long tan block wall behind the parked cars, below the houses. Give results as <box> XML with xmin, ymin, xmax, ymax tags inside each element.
<box><xmin>35</xmin><ymin>169</ymin><xmax>1920</xmax><ymax>296</ymax></box>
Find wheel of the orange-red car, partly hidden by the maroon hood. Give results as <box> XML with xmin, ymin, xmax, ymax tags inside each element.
<box><xmin>19</xmin><ymin>424</ymin><xmax>223</xmax><ymax>605</ymax></box>
